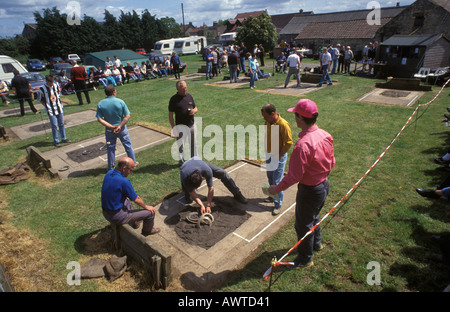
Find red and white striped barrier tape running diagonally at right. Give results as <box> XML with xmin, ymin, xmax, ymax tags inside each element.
<box><xmin>263</xmin><ymin>79</ymin><xmax>450</xmax><ymax>280</ymax></box>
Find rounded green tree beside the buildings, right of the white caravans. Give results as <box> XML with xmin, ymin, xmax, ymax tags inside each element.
<box><xmin>236</xmin><ymin>12</ymin><xmax>278</xmax><ymax>51</ymax></box>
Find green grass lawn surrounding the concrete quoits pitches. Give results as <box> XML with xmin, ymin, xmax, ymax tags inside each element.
<box><xmin>0</xmin><ymin>56</ymin><xmax>450</xmax><ymax>292</ymax></box>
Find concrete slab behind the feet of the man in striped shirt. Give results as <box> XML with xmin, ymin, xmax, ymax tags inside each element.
<box><xmin>9</xmin><ymin>109</ymin><xmax>97</xmax><ymax>140</ymax></box>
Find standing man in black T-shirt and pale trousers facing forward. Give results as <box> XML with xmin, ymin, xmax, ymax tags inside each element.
<box><xmin>169</xmin><ymin>80</ymin><xmax>197</xmax><ymax>165</ymax></box>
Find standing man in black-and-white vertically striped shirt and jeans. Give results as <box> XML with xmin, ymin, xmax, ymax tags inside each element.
<box><xmin>38</xmin><ymin>75</ymin><xmax>70</xmax><ymax>147</ymax></box>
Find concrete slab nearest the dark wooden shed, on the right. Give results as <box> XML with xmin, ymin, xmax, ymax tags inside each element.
<box><xmin>357</xmin><ymin>88</ymin><xmax>425</xmax><ymax>107</ymax></box>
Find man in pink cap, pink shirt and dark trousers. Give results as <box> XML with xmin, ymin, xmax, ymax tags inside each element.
<box><xmin>269</xmin><ymin>99</ymin><xmax>336</xmax><ymax>267</ymax></box>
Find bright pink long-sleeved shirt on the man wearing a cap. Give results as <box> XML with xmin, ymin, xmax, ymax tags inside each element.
<box><xmin>275</xmin><ymin>125</ymin><xmax>336</xmax><ymax>193</ymax></box>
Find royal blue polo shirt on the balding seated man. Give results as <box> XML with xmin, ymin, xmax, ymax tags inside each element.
<box><xmin>101</xmin><ymin>169</ymin><xmax>137</xmax><ymax>210</ymax></box>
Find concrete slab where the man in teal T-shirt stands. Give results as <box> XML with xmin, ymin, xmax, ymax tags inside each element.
<box><xmin>43</xmin><ymin>126</ymin><xmax>172</xmax><ymax>179</ymax></box>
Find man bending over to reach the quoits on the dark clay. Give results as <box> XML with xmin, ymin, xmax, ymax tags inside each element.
<box><xmin>180</xmin><ymin>156</ymin><xmax>248</xmax><ymax>214</ymax></box>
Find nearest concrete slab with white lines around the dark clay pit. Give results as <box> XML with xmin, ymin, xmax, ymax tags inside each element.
<box><xmin>146</xmin><ymin>161</ymin><xmax>296</xmax><ymax>291</ymax></box>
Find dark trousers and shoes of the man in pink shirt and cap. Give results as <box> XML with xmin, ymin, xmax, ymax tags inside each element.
<box><xmin>294</xmin><ymin>180</ymin><xmax>330</xmax><ymax>264</ymax></box>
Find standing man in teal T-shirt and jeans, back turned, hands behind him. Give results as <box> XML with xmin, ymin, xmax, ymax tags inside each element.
<box><xmin>96</xmin><ymin>85</ymin><xmax>137</xmax><ymax>170</ymax></box>
